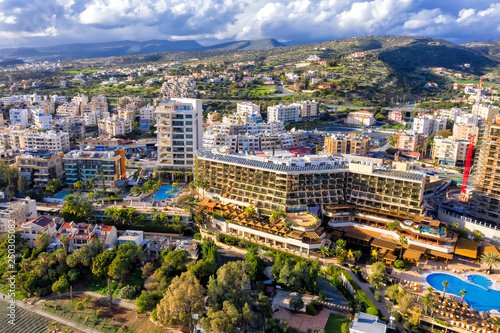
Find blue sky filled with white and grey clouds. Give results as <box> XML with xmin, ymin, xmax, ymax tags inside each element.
<box><xmin>0</xmin><ymin>0</ymin><xmax>500</xmax><ymax>47</ymax></box>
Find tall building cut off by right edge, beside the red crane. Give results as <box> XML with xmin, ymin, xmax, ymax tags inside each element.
<box><xmin>469</xmin><ymin>116</ymin><xmax>500</xmax><ymax>226</ymax></box>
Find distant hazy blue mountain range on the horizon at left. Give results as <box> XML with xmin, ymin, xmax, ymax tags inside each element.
<box><xmin>0</xmin><ymin>39</ymin><xmax>284</xmax><ymax>60</ymax></box>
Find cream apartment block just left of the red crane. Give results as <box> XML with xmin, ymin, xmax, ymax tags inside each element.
<box><xmin>432</xmin><ymin>136</ymin><xmax>469</xmax><ymax>165</ymax></box>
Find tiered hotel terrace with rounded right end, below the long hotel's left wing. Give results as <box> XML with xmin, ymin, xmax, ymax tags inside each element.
<box><xmin>198</xmin><ymin>199</ymin><xmax>330</xmax><ymax>255</ymax></box>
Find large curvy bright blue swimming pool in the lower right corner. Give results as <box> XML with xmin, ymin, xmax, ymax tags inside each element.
<box><xmin>426</xmin><ymin>273</ymin><xmax>500</xmax><ymax>311</ymax></box>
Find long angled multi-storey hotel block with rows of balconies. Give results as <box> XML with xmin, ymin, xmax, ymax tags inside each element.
<box><xmin>195</xmin><ymin>148</ymin><xmax>425</xmax><ymax>214</ymax></box>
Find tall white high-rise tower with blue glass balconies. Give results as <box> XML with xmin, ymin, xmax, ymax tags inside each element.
<box><xmin>155</xmin><ymin>98</ymin><xmax>203</xmax><ymax>170</ymax></box>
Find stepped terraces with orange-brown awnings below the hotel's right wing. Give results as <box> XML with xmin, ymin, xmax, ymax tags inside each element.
<box><xmin>323</xmin><ymin>205</ymin><xmax>458</xmax><ymax>263</ymax></box>
